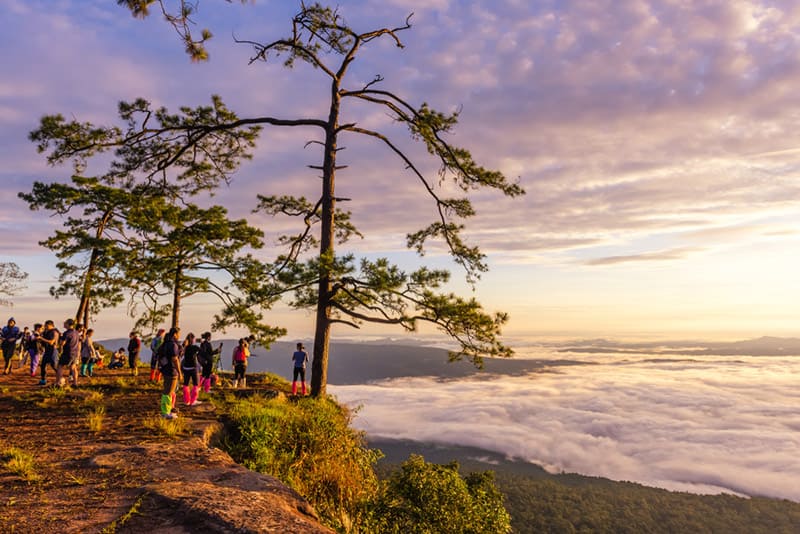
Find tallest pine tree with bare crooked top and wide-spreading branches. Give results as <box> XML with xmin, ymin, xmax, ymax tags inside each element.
<box><xmin>31</xmin><ymin>0</ymin><xmax>524</xmax><ymax>396</ymax></box>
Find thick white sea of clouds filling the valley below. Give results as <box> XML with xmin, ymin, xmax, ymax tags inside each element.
<box><xmin>329</xmin><ymin>354</ymin><xmax>800</xmax><ymax>501</ymax></box>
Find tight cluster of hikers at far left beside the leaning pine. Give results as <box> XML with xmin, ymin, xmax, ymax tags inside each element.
<box><xmin>0</xmin><ymin>317</ymin><xmax>102</xmax><ymax>386</ymax></box>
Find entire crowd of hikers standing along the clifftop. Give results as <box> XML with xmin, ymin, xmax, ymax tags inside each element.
<box><xmin>0</xmin><ymin>317</ymin><xmax>309</xmax><ymax>419</ymax></box>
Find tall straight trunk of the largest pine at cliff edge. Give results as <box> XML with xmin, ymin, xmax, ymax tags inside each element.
<box><xmin>311</xmin><ymin>80</ymin><xmax>340</xmax><ymax>397</ymax></box>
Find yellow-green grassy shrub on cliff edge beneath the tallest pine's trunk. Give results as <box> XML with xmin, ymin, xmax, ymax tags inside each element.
<box><xmin>223</xmin><ymin>396</ymin><xmax>380</xmax><ymax>532</ymax></box>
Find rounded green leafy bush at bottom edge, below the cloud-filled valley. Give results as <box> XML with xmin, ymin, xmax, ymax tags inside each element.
<box><xmin>370</xmin><ymin>455</ymin><xmax>511</xmax><ymax>534</ymax></box>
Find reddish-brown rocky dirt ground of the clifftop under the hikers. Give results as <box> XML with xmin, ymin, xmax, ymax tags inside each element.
<box><xmin>0</xmin><ymin>361</ymin><xmax>330</xmax><ymax>533</ymax></box>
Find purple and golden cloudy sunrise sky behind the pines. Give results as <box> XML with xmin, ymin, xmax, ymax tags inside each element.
<box><xmin>0</xmin><ymin>0</ymin><xmax>800</xmax><ymax>339</ymax></box>
